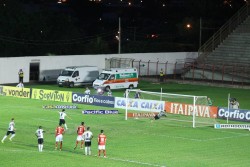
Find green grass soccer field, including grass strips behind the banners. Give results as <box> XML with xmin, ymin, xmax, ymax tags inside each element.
<box><xmin>0</xmin><ymin>83</ymin><xmax>250</xmax><ymax>167</ymax></box>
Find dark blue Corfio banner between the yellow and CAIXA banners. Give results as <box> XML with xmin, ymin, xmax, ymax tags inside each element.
<box><xmin>72</xmin><ymin>93</ymin><xmax>115</xmax><ymax>107</ymax></box>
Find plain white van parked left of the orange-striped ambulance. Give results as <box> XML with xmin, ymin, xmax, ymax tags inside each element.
<box><xmin>57</xmin><ymin>66</ymin><xmax>99</xmax><ymax>87</ymax></box>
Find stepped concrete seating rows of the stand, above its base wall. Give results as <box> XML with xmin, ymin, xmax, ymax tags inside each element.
<box><xmin>205</xmin><ymin>17</ymin><xmax>250</xmax><ymax>67</ymax></box>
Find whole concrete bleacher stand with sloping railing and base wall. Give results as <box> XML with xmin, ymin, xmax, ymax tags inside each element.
<box><xmin>183</xmin><ymin>4</ymin><xmax>250</xmax><ymax>83</ymax></box>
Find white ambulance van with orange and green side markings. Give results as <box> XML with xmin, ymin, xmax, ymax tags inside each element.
<box><xmin>93</xmin><ymin>68</ymin><xmax>138</xmax><ymax>91</ymax></box>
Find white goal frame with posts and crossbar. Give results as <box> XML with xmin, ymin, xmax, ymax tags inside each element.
<box><xmin>125</xmin><ymin>89</ymin><xmax>207</xmax><ymax>128</ymax></box>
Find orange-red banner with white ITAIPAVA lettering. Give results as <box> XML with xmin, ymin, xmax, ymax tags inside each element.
<box><xmin>165</xmin><ymin>102</ymin><xmax>218</xmax><ymax>118</ymax></box>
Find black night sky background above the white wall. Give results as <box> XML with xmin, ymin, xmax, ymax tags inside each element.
<box><xmin>0</xmin><ymin>0</ymin><xmax>246</xmax><ymax>55</ymax></box>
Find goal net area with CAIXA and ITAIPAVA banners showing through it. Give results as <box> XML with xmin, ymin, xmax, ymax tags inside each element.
<box><xmin>125</xmin><ymin>89</ymin><xmax>217</xmax><ymax>127</ymax></box>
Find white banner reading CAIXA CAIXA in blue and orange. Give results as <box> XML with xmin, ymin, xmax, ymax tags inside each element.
<box><xmin>115</xmin><ymin>97</ymin><xmax>165</xmax><ymax>112</ymax></box>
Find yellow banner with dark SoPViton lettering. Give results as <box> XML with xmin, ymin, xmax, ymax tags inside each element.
<box><xmin>31</xmin><ymin>89</ymin><xmax>72</xmax><ymax>103</ymax></box>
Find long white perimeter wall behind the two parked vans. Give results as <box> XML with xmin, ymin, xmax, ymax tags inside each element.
<box><xmin>0</xmin><ymin>52</ymin><xmax>198</xmax><ymax>84</ymax></box>
